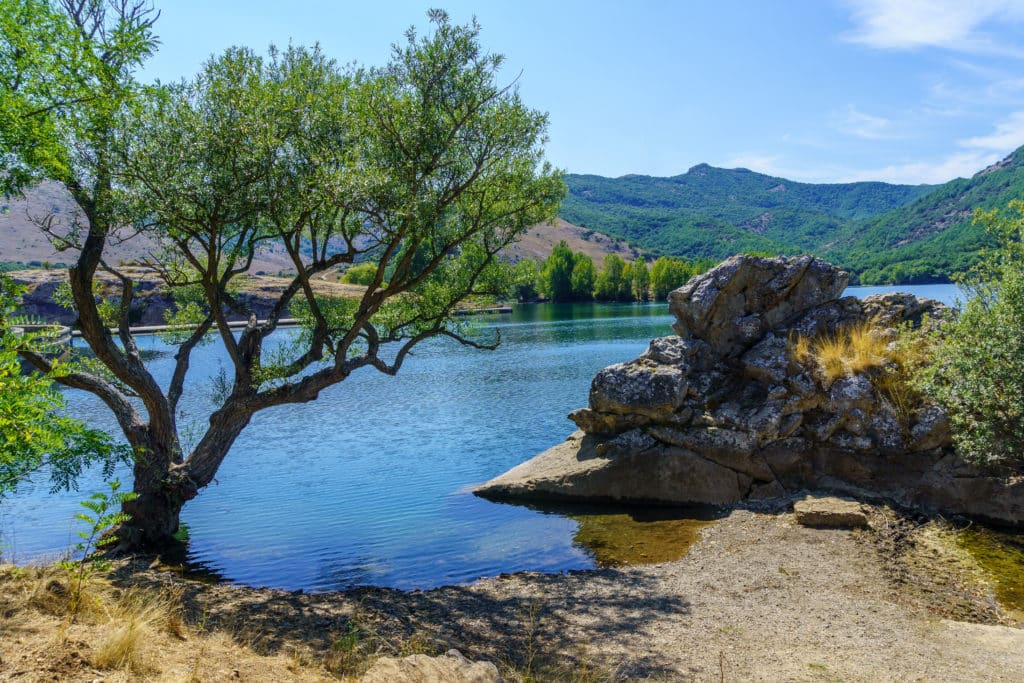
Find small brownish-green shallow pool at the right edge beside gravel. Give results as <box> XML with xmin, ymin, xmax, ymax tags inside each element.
<box><xmin>956</xmin><ymin>526</ymin><xmax>1024</xmax><ymax>620</ymax></box>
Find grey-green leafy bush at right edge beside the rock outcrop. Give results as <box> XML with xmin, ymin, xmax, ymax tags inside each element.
<box><xmin>919</xmin><ymin>200</ymin><xmax>1024</xmax><ymax>467</ymax></box>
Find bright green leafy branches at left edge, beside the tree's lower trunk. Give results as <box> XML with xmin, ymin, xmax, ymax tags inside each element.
<box><xmin>0</xmin><ymin>274</ymin><xmax>129</xmax><ymax>497</ymax></box>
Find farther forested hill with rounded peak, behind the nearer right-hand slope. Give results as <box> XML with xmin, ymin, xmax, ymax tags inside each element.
<box><xmin>561</xmin><ymin>164</ymin><xmax>932</xmax><ymax>266</ymax></box>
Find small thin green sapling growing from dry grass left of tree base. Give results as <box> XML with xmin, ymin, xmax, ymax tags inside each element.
<box><xmin>60</xmin><ymin>479</ymin><xmax>137</xmax><ymax>615</ymax></box>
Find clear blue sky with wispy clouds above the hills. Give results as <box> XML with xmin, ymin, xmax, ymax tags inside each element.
<box><xmin>143</xmin><ymin>0</ymin><xmax>1024</xmax><ymax>183</ymax></box>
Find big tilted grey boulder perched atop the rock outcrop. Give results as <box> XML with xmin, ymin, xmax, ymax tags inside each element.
<box><xmin>669</xmin><ymin>254</ymin><xmax>849</xmax><ymax>356</ymax></box>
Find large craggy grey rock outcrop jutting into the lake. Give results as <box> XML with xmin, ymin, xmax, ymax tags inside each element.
<box><xmin>477</xmin><ymin>256</ymin><xmax>1024</xmax><ymax>524</ymax></box>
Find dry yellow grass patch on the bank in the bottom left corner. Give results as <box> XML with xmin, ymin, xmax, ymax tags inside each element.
<box><xmin>0</xmin><ymin>565</ymin><xmax>332</xmax><ymax>683</ymax></box>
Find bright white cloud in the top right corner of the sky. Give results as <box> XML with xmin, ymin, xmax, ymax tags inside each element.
<box><xmin>845</xmin><ymin>0</ymin><xmax>1024</xmax><ymax>56</ymax></box>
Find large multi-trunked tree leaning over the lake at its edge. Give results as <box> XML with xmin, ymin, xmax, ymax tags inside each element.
<box><xmin>0</xmin><ymin>0</ymin><xmax>564</xmax><ymax>547</ymax></box>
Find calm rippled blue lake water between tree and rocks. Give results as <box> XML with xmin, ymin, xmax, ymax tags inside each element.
<box><xmin>0</xmin><ymin>285</ymin><xmax>956</xmax><ymax>591</ymax></box>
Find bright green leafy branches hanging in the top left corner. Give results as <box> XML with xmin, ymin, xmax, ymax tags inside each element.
<box><xmin>0</xmin><ymin>0</ymin><xmax>156</xmax><ymax>197</ymax></box>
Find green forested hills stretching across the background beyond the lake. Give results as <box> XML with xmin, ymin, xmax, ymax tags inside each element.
<box><xmin>561</xmin><ymin>147</ymin><xmax>1024</xmax><ymax>284</ymax></box>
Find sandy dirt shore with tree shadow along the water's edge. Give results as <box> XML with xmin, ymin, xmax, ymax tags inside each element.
<box><xmin>0</xmin><ymin>510</ymin><xmax>1024</xmax><ymax>681</ymax></box>
